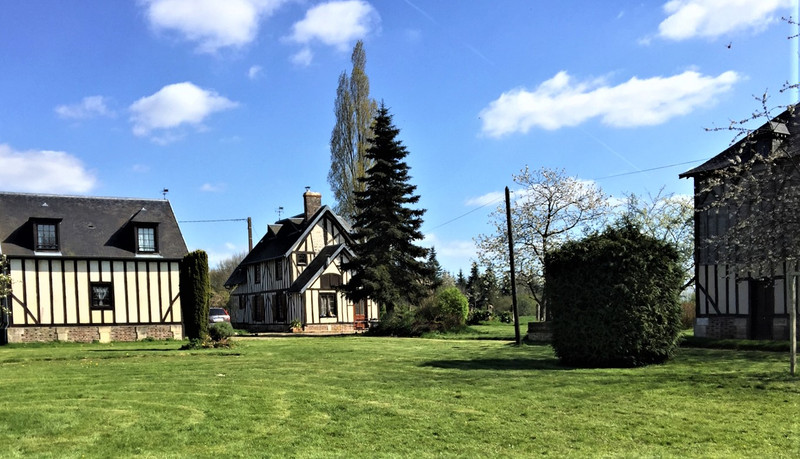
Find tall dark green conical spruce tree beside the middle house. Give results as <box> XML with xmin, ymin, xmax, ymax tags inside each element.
<box><xmin>342</xmin><ymin>103</ymin><xmax>432</xmax><ymax>313</ymax></box>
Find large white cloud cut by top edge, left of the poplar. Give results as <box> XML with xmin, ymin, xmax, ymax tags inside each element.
<box><xmin>143</xmin><ymin>0</ymin><xmax>286</xmax><ymax>53</ymax></box>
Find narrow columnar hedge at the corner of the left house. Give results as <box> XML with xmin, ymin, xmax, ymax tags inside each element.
<box><xmin>180</xmin><ymin>250</ymin><xmax>211</xmax><ymax>339</ymax></box>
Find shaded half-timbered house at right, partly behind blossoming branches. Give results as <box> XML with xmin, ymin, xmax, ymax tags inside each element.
<box><xmin>680</xmin><ymin>106</ymin><xmax>800</xmax><ymax>339</ymax></box>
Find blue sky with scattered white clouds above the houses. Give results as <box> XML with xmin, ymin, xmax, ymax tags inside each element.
<box><xmin>0</xmin><ymin>0</ymin><xmax>798</xmax><ymax>272</ymax></box>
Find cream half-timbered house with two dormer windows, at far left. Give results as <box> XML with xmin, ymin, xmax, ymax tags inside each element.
<box><xmin>0</xmin><ymin>193</ymin><xmax>187</xmax><ymax>342</ymax></box>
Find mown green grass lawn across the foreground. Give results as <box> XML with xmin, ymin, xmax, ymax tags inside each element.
<box><xmin>0</xmin><ymin>337</ymin><xmax>800</xmax><ymax>458</ymax></box>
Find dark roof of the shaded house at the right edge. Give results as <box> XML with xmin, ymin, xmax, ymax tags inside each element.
<box><xmin>678</xmin><ymin>106</ymin><xmax>800</xmax><ymax>178</ymax></box>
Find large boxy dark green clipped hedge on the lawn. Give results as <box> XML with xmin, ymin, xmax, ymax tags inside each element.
<box><xmin>546</xmin><ymin>222</ymin><xmax>682</xmax><ymax>367</ymax></box>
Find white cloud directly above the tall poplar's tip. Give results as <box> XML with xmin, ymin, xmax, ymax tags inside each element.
<box><xmin>289</xmin><ymin>0</ymin><xmax>380</xmax><ymax>51</ymax></box>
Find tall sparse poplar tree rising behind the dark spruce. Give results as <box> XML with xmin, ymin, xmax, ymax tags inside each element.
<box><xmin>328</xmin><ymin>40</ymin><xmax>377</xmax><ymax>221</ymax></box>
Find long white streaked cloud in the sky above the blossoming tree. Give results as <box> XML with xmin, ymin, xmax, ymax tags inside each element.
<box><xmin>480</xmin><ymin>71</ymin><xmax>739</xmax><ymax>137</ymax></box>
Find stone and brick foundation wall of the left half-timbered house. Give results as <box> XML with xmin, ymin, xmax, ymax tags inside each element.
<box><xmin>8</xmin><ymin>325</ymin><xmax>183</xmax><ymax>343</ymax></box>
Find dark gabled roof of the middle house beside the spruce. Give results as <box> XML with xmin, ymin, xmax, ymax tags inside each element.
<box><xmin>225</xmin><ymin>206</ymin><xmax>350</xmax><ymax>287</ymax></box>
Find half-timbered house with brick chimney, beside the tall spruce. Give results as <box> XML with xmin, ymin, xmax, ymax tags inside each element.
<box><xmin>225</xmin><ymin>191</ymin><xmax>378</xmax><ymax>333</ymax></box>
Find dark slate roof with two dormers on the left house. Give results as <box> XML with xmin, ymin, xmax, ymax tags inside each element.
<box><xmin>0</xmin><ymin>193</ymin><xmax>188</xmax><ymax>259</ymax></box>
